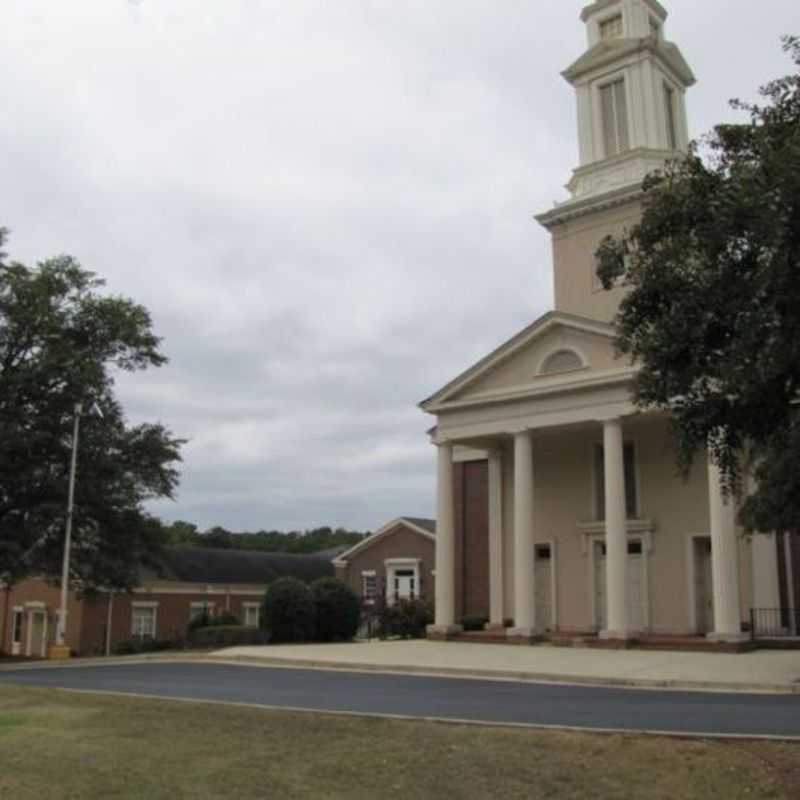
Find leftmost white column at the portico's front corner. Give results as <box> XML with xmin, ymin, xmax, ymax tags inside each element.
<box><xmin>428</xmin><ymin>442</ymin><xmax>461</xmax><ymax>635</ymax></box>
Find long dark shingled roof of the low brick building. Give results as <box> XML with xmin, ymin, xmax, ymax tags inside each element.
<box><xmin>148</xmin><ymin>547</ymin><xmax>333</xmax><ymax>584</ymax></box>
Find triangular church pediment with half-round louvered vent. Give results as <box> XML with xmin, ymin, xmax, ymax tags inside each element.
<box><xmin>422</xmin><ymin>312</ymin><xmax>624</xmax><ymax>410</ymax></box>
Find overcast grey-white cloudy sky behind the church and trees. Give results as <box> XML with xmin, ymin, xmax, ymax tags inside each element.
<box><xmin>0</xmin><ymin>0</ymin><xmax>800</xmax><ymax>530</ymax></box>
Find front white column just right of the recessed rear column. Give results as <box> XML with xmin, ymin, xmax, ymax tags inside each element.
<box><xmin>508</xmin><ymin>431</ymin><xmax>536</xmax><ymax>638</ymax></box>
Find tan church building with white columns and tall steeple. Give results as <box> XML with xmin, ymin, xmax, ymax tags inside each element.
<box><xmin>421</xmin><ymin>0</ymin><xmax>798</xmax><ymax>642</ymax></box>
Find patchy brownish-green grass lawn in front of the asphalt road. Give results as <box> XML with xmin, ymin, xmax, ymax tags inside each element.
<box><xmin>0</xmin><ymin>686</ymin><xmax>800</xmax><ymax>800</ymax></box>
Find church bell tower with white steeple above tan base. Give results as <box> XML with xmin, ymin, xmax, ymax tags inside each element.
<box><xmin>537</xmin><ymin>0</ymin><xmax>695</xmax><ymax>321</ymax></box>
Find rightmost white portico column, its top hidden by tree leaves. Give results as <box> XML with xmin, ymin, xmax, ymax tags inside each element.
<box><xmin>708</xmin><ymin>458</ymin><xmax>744</xmax><ymax>641</ymax></box>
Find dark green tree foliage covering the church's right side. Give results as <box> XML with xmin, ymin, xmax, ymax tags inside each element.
<box><xmin>597</xmin><ymin>38</ymin><xmax>800</xmax><ymax>530</ymax></box>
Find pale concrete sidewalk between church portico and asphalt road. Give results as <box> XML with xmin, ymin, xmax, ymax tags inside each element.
<box><xmin>211</xmin><ymin>641</ymin><xmax>800</xmax><ymax>694</ymax></box>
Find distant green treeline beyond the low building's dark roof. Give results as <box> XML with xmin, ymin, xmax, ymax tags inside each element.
<box><xmin>164</xmin><ymin>520</ymin><xmax>369</xmax><ymax>553</ymax></box>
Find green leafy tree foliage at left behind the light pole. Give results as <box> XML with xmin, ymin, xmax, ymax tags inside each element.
<box><xmin>0</xmin><ymin>230</ymin><xmax>181</xmax><ymax>591</ymax></box>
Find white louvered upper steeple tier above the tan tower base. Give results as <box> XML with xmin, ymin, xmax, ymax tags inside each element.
<box><xmin>563</xmin><ymin>0</ymin><xmax>695</xmax><ymax>202</ymax></box>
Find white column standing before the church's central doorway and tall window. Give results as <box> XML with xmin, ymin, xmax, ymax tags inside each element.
<box><xmin>600</xmin><ymin>418</ymin><xmax>630</xmax><ymax>639</ymax></box>
